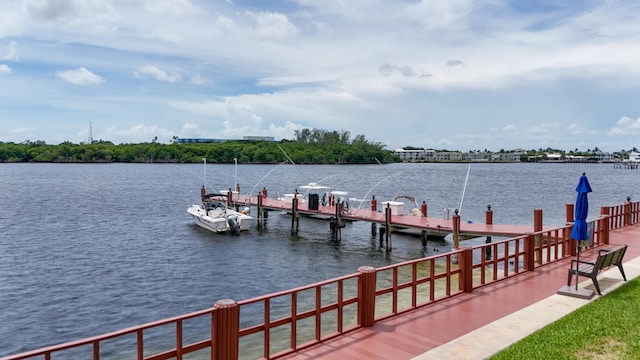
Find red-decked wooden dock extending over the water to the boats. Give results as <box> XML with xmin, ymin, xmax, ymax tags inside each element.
<box><xmin>233</xmin><ymin>195</ymin><xmax>545</xmax><ymax>238</ymax></box>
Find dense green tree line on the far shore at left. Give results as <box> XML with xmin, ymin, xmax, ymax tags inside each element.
<box><xmin>0</xmin><ymin>129</ymin><xmax>399</xmax><ymax>164</ymax></box>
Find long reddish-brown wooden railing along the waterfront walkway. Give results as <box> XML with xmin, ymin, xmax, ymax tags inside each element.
<box><xmin>0</xmin><ymin>203</ymin><xmax>637</xmax><ymax>360</ymax></box>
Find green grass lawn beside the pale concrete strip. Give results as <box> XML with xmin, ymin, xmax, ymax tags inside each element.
<box><xmin>490</xmin><ymin>279</ymin><xmax>640</xmax><ymax>360</ymax></box>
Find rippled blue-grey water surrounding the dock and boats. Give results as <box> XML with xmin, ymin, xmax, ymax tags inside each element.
<box><xmin>0</xmin><ymin>164</ymin><xmax>640</xmax><ymax>356</ymax></box>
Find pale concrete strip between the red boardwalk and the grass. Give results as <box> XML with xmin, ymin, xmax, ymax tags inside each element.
<box><xmin>413</xmin><ymin>258</ymin><xmax>640</xmax><ymax>360</ymax></box>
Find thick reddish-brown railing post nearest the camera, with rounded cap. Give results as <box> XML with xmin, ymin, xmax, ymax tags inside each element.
<box><xmin>211</xmin><ymin>299</ymin><xmax>240</xmax><ymax>360</ymax></box>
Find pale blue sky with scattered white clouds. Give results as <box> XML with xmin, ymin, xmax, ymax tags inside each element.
<box><xmin>0</xmin><ymin>0</ymin><xmax>640</xmax><ymax>152</ymax></box>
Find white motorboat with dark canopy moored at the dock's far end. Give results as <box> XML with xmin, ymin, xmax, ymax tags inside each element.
<box><xmin>187</xmin><ymin>194</ymin><xmax>253</xmax><ymax>234</ymax></box>
